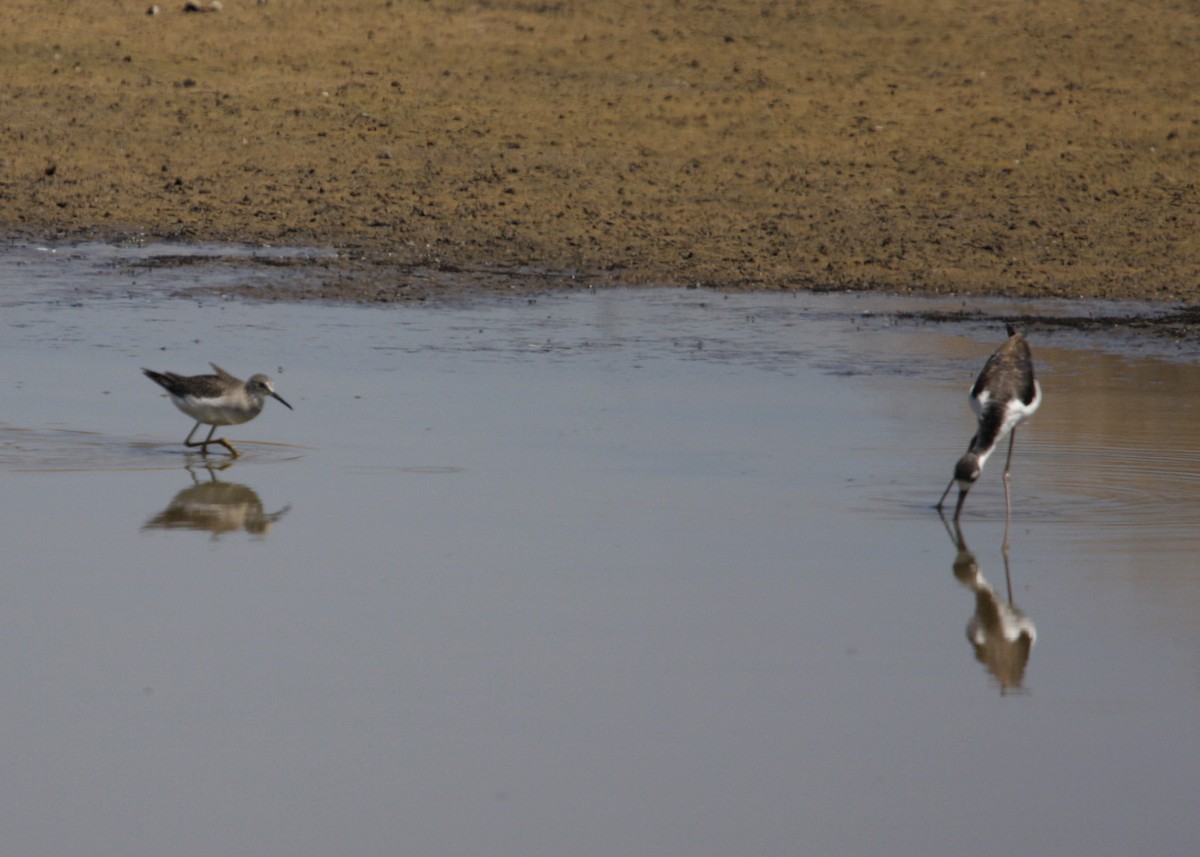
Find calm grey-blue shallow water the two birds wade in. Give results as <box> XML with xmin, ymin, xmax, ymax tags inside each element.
<box><xmin>0</xmin><ymin>240</ymin><xmax>1200</xmax><ymax>857</ymax></box>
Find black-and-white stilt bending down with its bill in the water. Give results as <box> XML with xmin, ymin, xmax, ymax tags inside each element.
<box><xmin>937</xmin><ymin>324</ymin><xmax>1042</xmax><ymax>521</ymax></box>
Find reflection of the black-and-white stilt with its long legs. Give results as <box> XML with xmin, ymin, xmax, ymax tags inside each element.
<box><xmin>942</xmin><ymin>517</ymin><xmax>1038</xmax><ymax>694</ymax></box>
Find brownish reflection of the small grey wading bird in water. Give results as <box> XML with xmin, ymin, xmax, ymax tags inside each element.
<box><xmin>142</xmin><ymin>467</ymin><xmax>292</xmax><ymax>539</ymax></box>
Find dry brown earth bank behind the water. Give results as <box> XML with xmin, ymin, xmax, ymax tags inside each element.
<box><xmin>0</xmin><ymin>0</ymin><xmax>1200</xmax><ymax>301</ymax></box>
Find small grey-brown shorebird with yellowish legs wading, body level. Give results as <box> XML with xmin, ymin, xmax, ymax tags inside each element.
<box><xmin>142</xmin><ymin>362</ymin><xmax>294</xmax><ymax>459</ymax></box>
